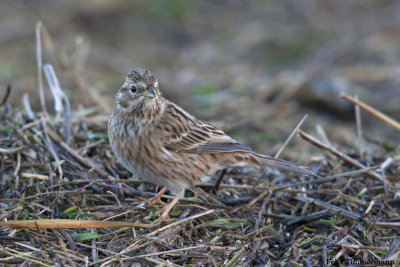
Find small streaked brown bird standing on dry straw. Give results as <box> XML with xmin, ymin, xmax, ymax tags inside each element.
<box><xmin>108</xmin><ymin>68</ymin><xmax>316</xmax><ymax>220</ymax></box>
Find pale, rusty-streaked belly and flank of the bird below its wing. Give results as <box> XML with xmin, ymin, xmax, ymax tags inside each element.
<box><xmin>110</xmin><ymin>127</ymin><xmax>216</xmax><ymax>195</ymax></box>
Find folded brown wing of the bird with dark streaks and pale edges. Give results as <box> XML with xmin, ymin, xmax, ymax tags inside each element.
<box><xmin>153</xmin><ymin>102</ymin><xmax>251</xmax><ymax>153</ymax></box>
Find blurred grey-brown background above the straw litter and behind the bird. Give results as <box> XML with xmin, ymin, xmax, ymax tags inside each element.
<box><xmin>0</xmin><ymin>0</ymin><xmax>400</xmax><ymax>158</ymax></box>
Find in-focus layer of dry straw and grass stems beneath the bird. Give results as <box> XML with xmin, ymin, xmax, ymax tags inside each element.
<box><xmin>0</xmin><ymin>12</ymin><xmax>400</xmax><ymax>266</ymax></box>
